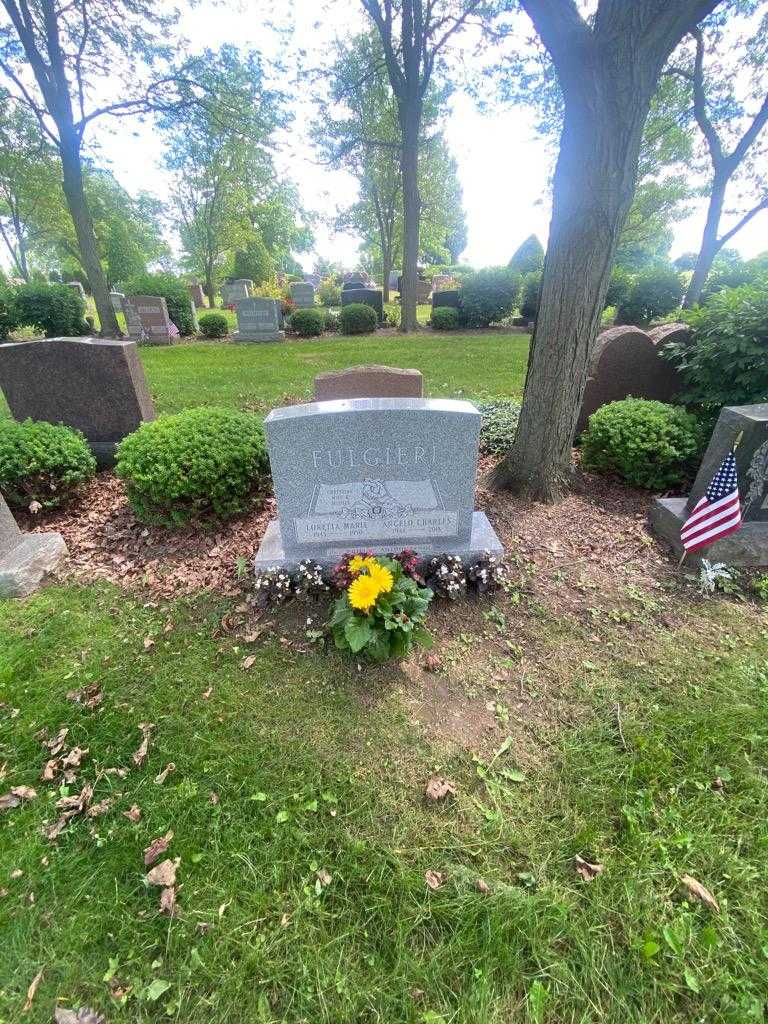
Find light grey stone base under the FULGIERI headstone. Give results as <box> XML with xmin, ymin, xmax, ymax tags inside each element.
<box><xmin>254</xmin><ymin>512</ymin><xmax>504</xmax><ymax>571</ymax></box>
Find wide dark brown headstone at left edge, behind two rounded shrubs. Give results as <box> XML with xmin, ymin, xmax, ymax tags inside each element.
<box><xmin>0</xmin><ymin>338</ymin><xmax>155</xmax><ymax>466</ymax></box>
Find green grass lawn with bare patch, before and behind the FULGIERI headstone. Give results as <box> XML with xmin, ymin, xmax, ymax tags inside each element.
<box><xmin>0</xmin><ymin>335</ymin><xmax>768</xmax><ymax>1024</ymax></box>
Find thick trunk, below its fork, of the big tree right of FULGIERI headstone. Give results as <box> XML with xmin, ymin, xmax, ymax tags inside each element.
<box><xmin>488</xmin><ymin>83</ymin><xmax>652</xmax><ymax>501</ymax></box>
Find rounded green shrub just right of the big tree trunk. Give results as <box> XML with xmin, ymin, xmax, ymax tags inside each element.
<box><xmin>582</xmin><ymin>398</ymin><xmax>702</xmax><ymax>490</ymax></box>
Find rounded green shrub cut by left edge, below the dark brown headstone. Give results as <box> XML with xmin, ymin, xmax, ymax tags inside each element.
<box><xmin>0</xmin><ymin>417</ymin><xmax>96</xmax><ymax>509</ymax></box>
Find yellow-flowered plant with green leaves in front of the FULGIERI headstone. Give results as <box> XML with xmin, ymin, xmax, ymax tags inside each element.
<box><xmin>331</xmin><ymin>554</ymin><xmax>432</xmax><ymax>662</ymax></box>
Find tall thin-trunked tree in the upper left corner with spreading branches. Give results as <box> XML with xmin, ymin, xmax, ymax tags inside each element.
<box><xmin>0</xmin><ymin>0</ymin><xmax>186</xmax><ymax>335</ymax></box>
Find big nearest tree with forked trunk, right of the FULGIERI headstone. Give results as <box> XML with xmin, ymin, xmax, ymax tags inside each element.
<box><xmin>492</xmin><ymin>0</ymin><xmax>717</xmax><ymax>501</ymax></box>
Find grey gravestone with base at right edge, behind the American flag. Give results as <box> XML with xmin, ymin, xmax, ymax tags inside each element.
<box><xmin>649</xmin><ymin>403</ymin><xmax>768</xmax><ymax>565</ymax></box>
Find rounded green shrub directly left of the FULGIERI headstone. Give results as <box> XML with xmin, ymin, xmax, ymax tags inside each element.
<box><xmin>116</xmin><ymin>407</ymin><xmax>269</xmax><ymax>526</ymax></box>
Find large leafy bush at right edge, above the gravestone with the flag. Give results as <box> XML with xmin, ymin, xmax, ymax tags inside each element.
<box><xmin>664</xmin><ymin>285</ymin><xmax>768</xmax><ymax>410</ymax></box>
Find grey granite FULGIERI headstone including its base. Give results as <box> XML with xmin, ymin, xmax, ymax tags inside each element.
<box><xmin>256</xmin><ymin>398</ymin><xmax>502</xmax><ymax>568</ymax></box>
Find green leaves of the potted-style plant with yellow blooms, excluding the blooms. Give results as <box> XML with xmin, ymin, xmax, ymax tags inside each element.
<box><xmin>331</xmin><ymin>557</ymin><xmax>432</xmax><ymax>662</ymax></box>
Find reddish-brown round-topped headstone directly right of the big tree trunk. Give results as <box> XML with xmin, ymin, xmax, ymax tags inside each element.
<box><xmin>577</xmin><ymin>327</ymin><xmax>682</xmax><ymax>433</ymax></box>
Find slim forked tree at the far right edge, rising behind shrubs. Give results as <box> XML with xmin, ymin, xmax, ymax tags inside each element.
<box><xmin>670</xmin><ymin>0</ymin><xmax>768</xmax><ymax>308</ymax></box>
